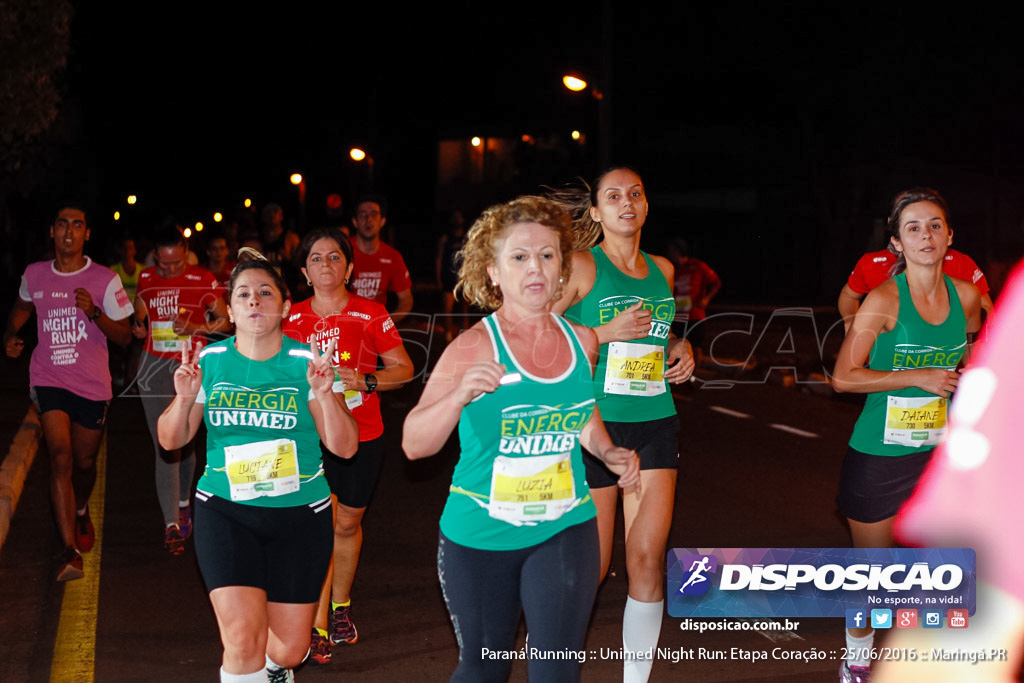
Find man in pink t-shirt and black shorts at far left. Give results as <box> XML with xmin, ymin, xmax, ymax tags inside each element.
<box><xmin>3</xmin><ymin>205</ymin><xmax>132</xmax><ymax>581</ymax></box>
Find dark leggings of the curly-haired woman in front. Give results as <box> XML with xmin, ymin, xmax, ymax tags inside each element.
<box><xmin>437</xmin><ymin>519</ymin><xmax>600</xmax><ymax>683</ymax></box>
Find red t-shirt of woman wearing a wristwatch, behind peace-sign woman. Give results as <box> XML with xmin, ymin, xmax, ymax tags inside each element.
<box><xmin>284</xmin><ymin>295</ymin><xmax>401</xmax><ymax>441</ymax></box>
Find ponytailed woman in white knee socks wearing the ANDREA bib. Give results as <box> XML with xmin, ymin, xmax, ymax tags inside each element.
<box><xmin>551</xmin><ymin>167</ymin><xmax>694</xmax><ymax>680</ymax></box>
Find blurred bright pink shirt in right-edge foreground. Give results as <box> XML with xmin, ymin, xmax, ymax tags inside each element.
<box><xmin>896</xmin><ymin>265</ymin><xmax>1024</xmax><ymax>601</ymax></box>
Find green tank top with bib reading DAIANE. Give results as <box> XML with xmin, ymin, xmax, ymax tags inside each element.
<box><xmin>850</xmin><ymin>273</ymin><xmax>967</xmax><ymax>456</ymax></box>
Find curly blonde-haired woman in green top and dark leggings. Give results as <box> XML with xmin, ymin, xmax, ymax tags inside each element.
<box><xmin>401</xmin><ymin>197</ymin><xmax>639</xmax><ymax>681</ymax></box>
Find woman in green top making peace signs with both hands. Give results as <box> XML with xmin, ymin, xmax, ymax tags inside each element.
<box><xmin>158</xmin><ymin>255</ymin><xmax>358</xmax><ymax>681</ymax></box>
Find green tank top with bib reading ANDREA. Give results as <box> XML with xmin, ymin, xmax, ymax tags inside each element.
<box><xmin>565</xmin><ymin>246</ymin><xmax>676</xmax><ymax>422</ymax></box>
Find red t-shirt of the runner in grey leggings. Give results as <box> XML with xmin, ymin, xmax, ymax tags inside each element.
<box><xmin>135</xmin><ymin>265</ymin><xmax>224</xmax><ymax>358</ymax></box>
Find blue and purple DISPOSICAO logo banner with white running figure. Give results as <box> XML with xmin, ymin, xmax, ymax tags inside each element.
<box><xmin>666</xmin><ymin>548</ymin><xmax>977</xmax><ymax>628</ymax></box>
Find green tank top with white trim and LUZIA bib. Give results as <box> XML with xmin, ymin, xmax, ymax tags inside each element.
<box><xmin>440</xmin><ymin>313</ymin><xmax>597</xmax><ymax>550</ymax></box>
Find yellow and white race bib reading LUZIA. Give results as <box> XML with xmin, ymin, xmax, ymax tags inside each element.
<box><xmin>488</xmin><ymin>453</ymin><xmax>575</xmax><ymax>525</ymax></box>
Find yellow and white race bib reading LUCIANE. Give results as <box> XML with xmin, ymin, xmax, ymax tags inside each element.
<box><xmin>224</xmin><ymin>438</ymin><xmax>299</xmax><ymax>501</ymax></box>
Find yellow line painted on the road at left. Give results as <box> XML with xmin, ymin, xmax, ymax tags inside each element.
<box><xmin>50</xmin><ymin>434</ymin><xmax>106</xmax><ymax>683</ymax></box>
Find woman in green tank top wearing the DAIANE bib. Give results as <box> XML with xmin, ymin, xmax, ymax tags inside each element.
<box><xmin>834</xmin><ymin>187</ymin><xmax>981</xmax><ymax>683</ymax></box>
